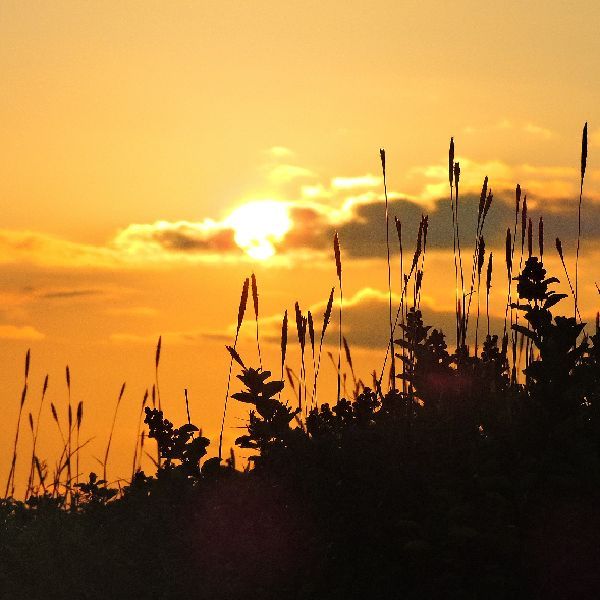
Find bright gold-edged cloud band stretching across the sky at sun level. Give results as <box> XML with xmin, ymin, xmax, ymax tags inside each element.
<box><xmin>0</xmin><ymin>152</ymin><xmax>600</xmax><ymax>270</ymax></box>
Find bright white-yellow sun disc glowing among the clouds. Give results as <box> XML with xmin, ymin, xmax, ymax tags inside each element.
<box><xmin>225</xmin><ymin>200</ymin><xmax>292</xmax><ymax>260</ymax></box>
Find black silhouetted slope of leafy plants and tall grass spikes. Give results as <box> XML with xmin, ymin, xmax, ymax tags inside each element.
<box><xmin>0</xmin><ymin>128</ymin><xmax>600</xmax><ymax>599</ymax></box>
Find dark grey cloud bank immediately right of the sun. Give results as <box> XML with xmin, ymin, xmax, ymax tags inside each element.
<box><xmin>284</xmin><ymin>192</ymin><xmax>600</xmax><ymax>258</ymax></box>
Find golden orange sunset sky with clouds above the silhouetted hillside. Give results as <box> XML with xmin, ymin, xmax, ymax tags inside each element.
<box><xmin>0</xmin><ymin>0</ymin><xmax>600</xmax><ymax>490</ymax></box>
